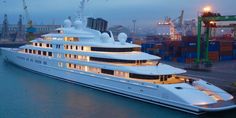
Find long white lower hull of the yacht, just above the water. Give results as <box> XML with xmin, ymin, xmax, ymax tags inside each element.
<box><xmin>2</xmin><ymin>49</ymin><xmax>235</xmax><ymax>115</ymax></box>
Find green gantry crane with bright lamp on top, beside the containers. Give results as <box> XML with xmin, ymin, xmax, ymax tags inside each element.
<box><xmin>195</xmin><ymin>7</ymin><xmax>236</xmax><ymax>67</ymax></box>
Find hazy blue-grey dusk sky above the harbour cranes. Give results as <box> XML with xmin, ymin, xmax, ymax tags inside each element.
<box><xmin>0</xmin><ymin>0</ymin><xmax>236</xmax><ymax>26</ymax></box>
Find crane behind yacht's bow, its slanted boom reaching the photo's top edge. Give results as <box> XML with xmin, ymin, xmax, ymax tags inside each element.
<box><xmin>22</xmin><ymin>0</ymin><xmax>36</xmax><ymax>41</ymax></box>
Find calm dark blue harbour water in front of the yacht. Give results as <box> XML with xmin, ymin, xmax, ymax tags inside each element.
<box><xmin>0</xmin><ymin>48</ymin><xmax>236</xmax><ymax>118</ymax></box>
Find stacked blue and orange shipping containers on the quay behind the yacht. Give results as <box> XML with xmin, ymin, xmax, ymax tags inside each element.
<box><xmin>136</xmin><ymin>37</ymin><xmax>236</xmax><ymax>63</ymax></box>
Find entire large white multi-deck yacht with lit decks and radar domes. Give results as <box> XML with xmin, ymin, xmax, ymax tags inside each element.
<box><xmin>2</xmin><ymin>19</ymin><xmax>236</xmax><ymax>114</ymax></box>
